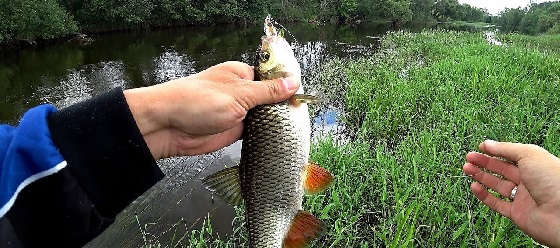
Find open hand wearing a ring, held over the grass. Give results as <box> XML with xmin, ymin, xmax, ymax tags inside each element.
<box><xmin>463</xmin><ymin>141</ymin><xmax>560</xmax><ymax>247</ymax></box>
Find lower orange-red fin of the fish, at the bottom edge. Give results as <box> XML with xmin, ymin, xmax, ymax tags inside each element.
<box><xmin>284</xmin><ymin>210</ymin><xmax>322</xmax><ymax>248</ymax></box>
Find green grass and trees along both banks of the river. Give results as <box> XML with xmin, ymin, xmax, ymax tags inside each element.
<box><xmin>0</xmin><ymin>0</ymin><xmax>560</xmax><ymax>247</ymax></box>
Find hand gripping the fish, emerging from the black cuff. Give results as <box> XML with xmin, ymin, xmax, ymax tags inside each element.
<box><xmin>124</xmin><ymin>62</ymin><xmax>300</xmax><ymax>159</ymax></box>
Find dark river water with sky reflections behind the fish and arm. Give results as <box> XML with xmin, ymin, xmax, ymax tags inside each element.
<box><xmin>0</xmin><ymin>24</ymin><xmax>389</xmax><ymax>247</ymax></box>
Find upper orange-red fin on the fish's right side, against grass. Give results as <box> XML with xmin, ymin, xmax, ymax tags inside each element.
<box><xmin>303</xmin><ymin>162</ymin><xmax>334</xmax><ymax>194</ymax></box>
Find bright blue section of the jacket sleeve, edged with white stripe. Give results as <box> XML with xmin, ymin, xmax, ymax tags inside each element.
<box><xmin>0</xmin><ymin>105</ymin><xmax>66</xmax><ymax>218</ymax></box>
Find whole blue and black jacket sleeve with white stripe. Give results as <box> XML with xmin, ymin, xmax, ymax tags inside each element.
<box><xmin>0</xmin><ymin>89</ymin><xmax>164</xmax><ymax>247</ymax></box>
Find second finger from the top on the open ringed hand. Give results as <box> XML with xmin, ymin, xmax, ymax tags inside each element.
<box><xmin>463</xmin><ymin>152</ymin><xmax>520</xmax><ymax>185</ymax></box>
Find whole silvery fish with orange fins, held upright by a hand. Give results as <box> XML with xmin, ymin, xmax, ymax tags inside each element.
<box><xmin>203</xmin><ymin>16</ymin><xmax>333</xmax><ymax>248</ymax></box>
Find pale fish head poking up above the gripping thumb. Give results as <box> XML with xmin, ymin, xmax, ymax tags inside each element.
<box><xmin>256</xmin><ymin>17</ymin><xmax>303</xmax><ymax>93</ymax></box>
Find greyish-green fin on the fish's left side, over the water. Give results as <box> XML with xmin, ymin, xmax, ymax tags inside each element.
<box><xmin>202</xmin><ymin>166</ymin><xmax>243</xmax><ymax>205</ymax></box>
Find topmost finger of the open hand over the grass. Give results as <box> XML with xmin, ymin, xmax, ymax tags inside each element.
<box><xmin>479</xmin><ymin>140</ymin><xmax>536</xmax><ymax>163</ymax></box>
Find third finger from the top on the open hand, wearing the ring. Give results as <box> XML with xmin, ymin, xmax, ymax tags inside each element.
<box><xmin>463</xmin><ymin>163</ymin><xmax>516</xmax><ymax>198</ymax></box>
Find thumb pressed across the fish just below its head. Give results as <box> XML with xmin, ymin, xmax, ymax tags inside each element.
<box><xmin>241</xmin><ymin>78</ymin><xmax>300</xmax><ymax>108</ymax></box>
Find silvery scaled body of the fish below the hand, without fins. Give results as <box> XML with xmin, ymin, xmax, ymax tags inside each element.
<box><xmin>239</xmin><ymin>102</ymin><xmax>310</xmax><ymax>247</ymax></box>
